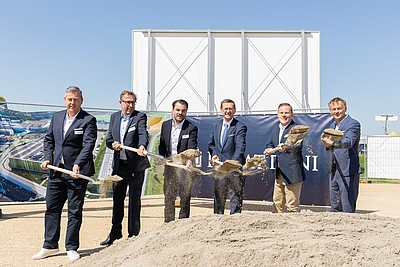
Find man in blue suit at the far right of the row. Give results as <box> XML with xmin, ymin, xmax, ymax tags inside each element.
<box><xmin>323</xmin><ymin>97</ymin><xmax>361</xmax><ymax>213</ymax></box>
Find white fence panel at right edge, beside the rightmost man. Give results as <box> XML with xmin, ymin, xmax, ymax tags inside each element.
<box><xmin>367</xmin><ymin>136</ymin><xmax>400</xmax><ymax>179</ymax></box>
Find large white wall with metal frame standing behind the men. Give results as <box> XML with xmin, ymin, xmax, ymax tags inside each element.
<box><xmin>131</xmin><ymin>29</ymin><xmax>320</xmax><ymax>114</ymax></box>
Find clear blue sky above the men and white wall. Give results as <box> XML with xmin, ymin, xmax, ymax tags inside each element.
<box><xmin>0</xmin><ymin>0</ymin><xmax>400</xmax><ymax>135</ymax></box>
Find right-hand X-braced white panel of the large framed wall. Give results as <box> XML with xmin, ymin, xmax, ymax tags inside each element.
<box><xmin>246</xmin><ymin>34</ymin><xmax>302</xmax><ymax>110</ymax></box>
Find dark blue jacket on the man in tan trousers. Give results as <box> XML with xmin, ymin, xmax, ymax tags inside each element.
<box><xmin>266</xmin><ymin>120</ymin><xmax>306</xmax><ymax>184</ymax></box>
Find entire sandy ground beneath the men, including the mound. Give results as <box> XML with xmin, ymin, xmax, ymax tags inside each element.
<box><xmin>0</xmin><ymin>184</ymin><xmax>400</xmax><ymax>267</ymax></box>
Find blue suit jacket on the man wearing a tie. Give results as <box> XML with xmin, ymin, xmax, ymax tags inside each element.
<box><xmin>208</xmin><ymin>118</ymin><xmax>247</xmax><ymax>165</ymax></box>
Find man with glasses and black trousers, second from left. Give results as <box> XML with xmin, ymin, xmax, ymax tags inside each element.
<box><xmin>100</xmin><ymin>90</ymin><xmax>150</xmax><ymax>246</ymax></box>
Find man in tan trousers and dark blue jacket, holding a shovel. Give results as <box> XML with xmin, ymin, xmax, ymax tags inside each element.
<box><xmin>264</xmin><ymin>103</ymin><xmax>306</xmax><ymax>213</ymax></box>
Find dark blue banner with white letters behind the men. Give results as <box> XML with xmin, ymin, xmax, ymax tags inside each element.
<box><xmin>187</xmin><ymin>113</ymin><xmax>333</xmax><ymax>206</ymax></box>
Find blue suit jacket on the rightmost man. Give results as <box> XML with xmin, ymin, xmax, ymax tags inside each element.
<box><xmin>330</xmin><ymin>115</ymin><xmax>361</xmax><ymax>176</ymax></box>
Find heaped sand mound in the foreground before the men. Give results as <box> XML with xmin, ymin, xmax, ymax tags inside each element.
<box><xmin>72</xmin><ymin>213</ymin><xmax>400</xmax><ymax>267</ymax></box>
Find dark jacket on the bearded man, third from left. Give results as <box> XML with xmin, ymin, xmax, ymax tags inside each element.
<box><xmin>158</xmin><ymin>119</ymin><xmax>198</xmax><ymax>158</ymax></box>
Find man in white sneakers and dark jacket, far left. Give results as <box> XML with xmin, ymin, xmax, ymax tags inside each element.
<box><xmin>32</xmin><ymin>86</ymin><xmax>97</xmax><ymax>261</ymax></box>
